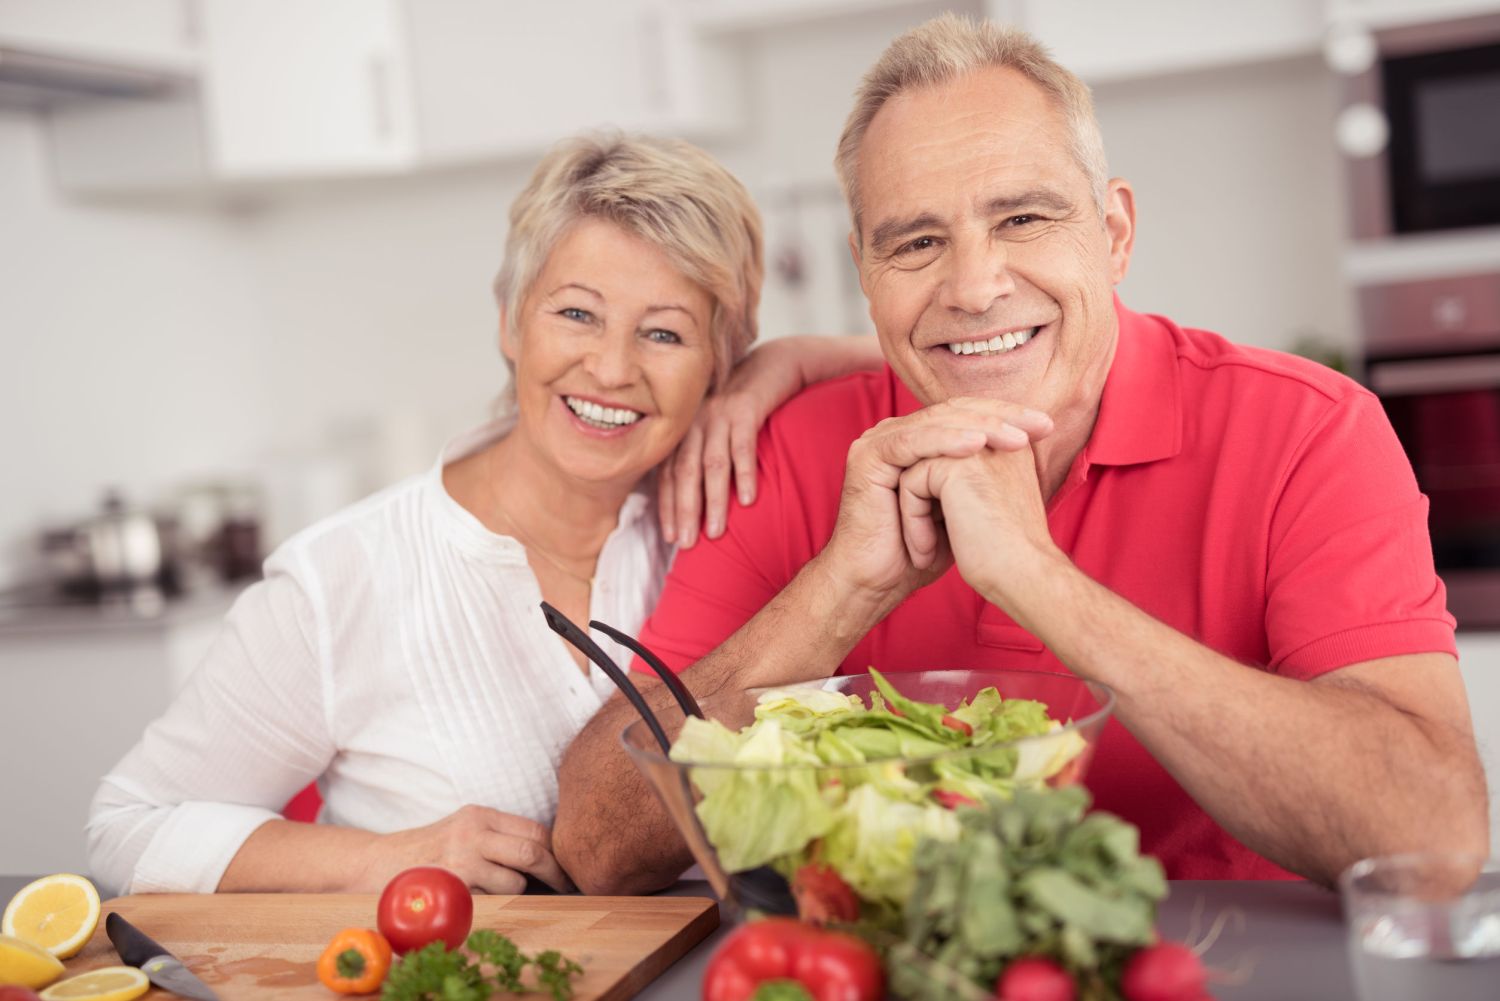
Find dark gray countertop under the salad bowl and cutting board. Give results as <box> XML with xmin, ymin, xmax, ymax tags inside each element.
<box><xmin>0</xmin><ymin>876</ymin><xmax>1362</xmax><ymax>1001</ymax></box>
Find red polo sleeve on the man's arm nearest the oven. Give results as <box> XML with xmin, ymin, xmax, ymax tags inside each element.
<box><xmin>1266</xmin><ymin>392</ymin><xmax>1457</xmax><ymax>680</ymax></box>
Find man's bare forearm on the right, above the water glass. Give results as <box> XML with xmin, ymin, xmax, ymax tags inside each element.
<box><xmin>984</xmin><ymin>557</ymin><xmax>1488</xmax><ymax>882</ymax></box>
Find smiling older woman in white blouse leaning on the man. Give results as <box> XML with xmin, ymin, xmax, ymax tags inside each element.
<box><xmin>87</xmin><ymin>138</ymin><xmax>876</xmax><ymax>893</ymax></box>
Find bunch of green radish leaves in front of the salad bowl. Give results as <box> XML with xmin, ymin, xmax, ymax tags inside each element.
<box><xmin>890</xmin><ymin>786</ymin><xmax>1167</xmax><ymax>1001</ymax></box>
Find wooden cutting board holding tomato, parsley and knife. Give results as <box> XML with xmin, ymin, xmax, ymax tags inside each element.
<box><xmin>66</xmin><ymin>893</ymin><xmax>719</xmax><ymax>1001</ymax></box>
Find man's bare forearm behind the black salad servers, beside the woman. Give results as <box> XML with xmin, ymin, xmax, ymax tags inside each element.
<box><xmin>552</xmin><ymin>560</ymin><xmax>899</xmax><ymax>894</ymax></box>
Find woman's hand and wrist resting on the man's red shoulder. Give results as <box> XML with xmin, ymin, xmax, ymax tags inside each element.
<box><xmin>657</xmin><ymin>335</ymin><xmax>882</xmax><ymax>549</ymax></box>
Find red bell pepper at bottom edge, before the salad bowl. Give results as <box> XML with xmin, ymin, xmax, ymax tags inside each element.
<box><xmin>704</xmin><ymin>917</ymin><xmax>885</xmax><ymax>1001</ymax></box>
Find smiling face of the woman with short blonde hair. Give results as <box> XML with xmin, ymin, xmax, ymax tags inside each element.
<box><xmin>501</xmin><ymin>219</ymin><xmax>714</xmax><ymax>488</ymax></box>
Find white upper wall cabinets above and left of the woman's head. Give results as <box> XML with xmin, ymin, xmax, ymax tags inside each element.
<box><xmin>50</xmin><ymin>0</ymin><xmax>737</xmax><ymax>192</ymax></box>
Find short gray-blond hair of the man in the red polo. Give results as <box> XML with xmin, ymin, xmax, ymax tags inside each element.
<box><xmin>834</xmin><ymin>12</ymin><xmax>1109</xmax><ymax>239</ymax></box>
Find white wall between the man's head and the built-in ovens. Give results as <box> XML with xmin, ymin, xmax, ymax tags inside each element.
<box><xmin>1095</xmin><ymin>59</ymin><xmax>1355</xmax><ymax>348</ymax></box>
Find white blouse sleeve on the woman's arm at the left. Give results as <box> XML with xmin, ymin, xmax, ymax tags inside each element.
<box><xmin>87</xmin><ymin>554</ymin><xmax>336</xmax><ymax>893</ymax></box>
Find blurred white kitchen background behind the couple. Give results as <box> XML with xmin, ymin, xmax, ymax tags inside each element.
<box><xmin>0</xmin><ymin>0</ymin><xmax>1500</xmax><ymax>873</ymax></box>
